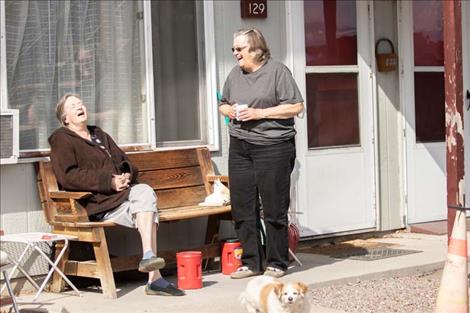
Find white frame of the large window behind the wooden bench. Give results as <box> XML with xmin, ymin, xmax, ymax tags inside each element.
<box><xmin>0</xmin><ymin>0</ymin><xmax>220</xmax><ymax>163</ymax></box>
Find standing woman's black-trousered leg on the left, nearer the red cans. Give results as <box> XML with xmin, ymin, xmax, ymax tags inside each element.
<box><xmin>229</xmin><ymin>137</ymin><xmax>263</xmax><ymax>272</ymax></box>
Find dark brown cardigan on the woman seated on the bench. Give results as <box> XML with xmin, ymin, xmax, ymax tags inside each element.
<box><xmin>49</xmin><ymin>126</ymin><xmax>138</xmax><ymax>215</ymax></box>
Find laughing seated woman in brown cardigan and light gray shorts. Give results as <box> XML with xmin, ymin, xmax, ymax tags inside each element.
<box><xmin>49</xmin><ymin>94</ymin><xmax>184</xmax><ymax>296</ymax></box>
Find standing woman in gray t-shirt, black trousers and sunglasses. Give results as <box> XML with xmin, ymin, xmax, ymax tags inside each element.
<box><xmin>219</xmin><ymin>28</ymin><xmax>303</xmax><ymax>279</ymax></box>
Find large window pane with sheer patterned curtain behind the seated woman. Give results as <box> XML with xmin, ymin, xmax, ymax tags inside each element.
<box><xmin>4</xmin><ymin>0</ymin><xmax>149</xmax><ymax>151</ymax></box>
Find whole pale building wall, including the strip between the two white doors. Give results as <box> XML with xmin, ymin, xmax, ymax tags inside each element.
<box><xmin>0</xmin><ymin>1</ymin><xmax>403</xmax><ymax>253</ymax></box>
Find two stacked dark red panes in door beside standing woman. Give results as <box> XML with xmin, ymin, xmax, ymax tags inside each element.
<box><xmin>304</xmin><ymin>0</ymin><xmax>360</xmax><ymax>149</ymax></box>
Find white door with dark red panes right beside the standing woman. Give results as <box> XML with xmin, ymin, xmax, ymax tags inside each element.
<box><xmin>291</xmin><ymin>0</ymin><xmax>376</xmax><ymax>237</ymax></box>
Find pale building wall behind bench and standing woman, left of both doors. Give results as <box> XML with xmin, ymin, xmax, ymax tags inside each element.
<box><xmin>0</xmin><ymin>1</ymin><xmax>286</xmax><ymax>254</ymax></box>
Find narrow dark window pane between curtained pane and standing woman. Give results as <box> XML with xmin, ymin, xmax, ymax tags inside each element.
<box><xmin>151</xmin><ymin>1</ymin><xmax>207</xmax><ymax>146</ymax></box>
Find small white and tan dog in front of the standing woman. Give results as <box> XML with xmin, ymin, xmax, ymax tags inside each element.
<box><xmin>240</xmin><ymin>275</ymin><xmax>310</xmax><ymax>313</ymax></box>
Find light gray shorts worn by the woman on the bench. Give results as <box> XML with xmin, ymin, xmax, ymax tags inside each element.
<box><xmin>102</xmin><ymin>184</ymin><xmax>158</xmax><ymax>228</ymax></box>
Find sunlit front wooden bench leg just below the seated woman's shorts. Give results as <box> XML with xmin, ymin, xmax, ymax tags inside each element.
<box><xmin>93</xmin><ymin>227</ymin><xmax>117</xmax><ymax>299</ymax></box>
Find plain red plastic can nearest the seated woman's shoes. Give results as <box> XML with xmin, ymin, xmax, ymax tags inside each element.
<box><xmin>176</xmin><ymin>251</ymin><xmax>202</xmax><ymax>289</ymax></box>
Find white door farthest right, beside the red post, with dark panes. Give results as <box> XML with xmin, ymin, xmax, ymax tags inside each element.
<box><xmin>398</xmin><ymin>1</ymin><xmax>447</xmax><ymax>224</ymax></box>
